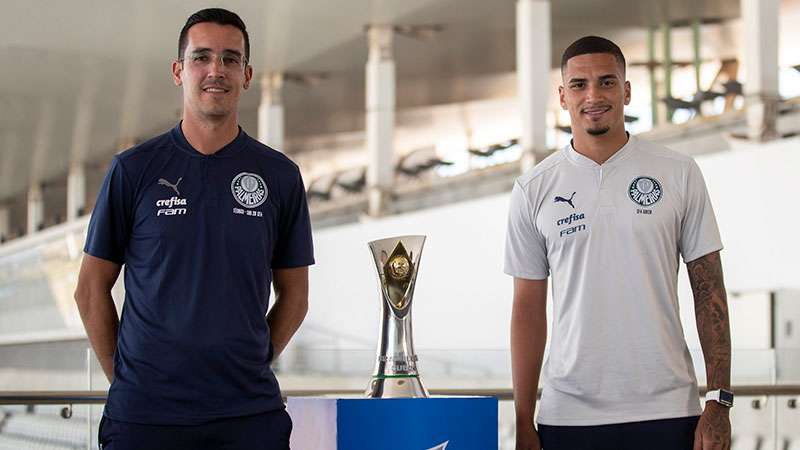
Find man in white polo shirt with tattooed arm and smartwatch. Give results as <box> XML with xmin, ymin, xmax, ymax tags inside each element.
<box><xmin>505</xmin><ymin>36</ymin><xmax>733</xmax><ymax>450</ymax></box>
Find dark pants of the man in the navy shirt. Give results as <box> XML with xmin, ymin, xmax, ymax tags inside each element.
<box><xmin>98</xmin><ymin>409</ymin><xmax>292</xmax><ymax>450</ymax></box>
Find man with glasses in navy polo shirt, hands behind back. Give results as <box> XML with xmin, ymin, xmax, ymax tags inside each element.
<box><xmin>75</xmin><ymin>8</ymin><xmax>314</xmax><ymax>450</ymax></box>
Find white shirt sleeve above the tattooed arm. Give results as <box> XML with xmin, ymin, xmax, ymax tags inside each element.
<box><xmin>679</xmin><ymin>160</ymin><xmax>722</xmax><ymax>263</ymax></box>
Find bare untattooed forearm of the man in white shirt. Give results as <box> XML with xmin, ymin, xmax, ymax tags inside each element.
<box><xmin>511</xmin><ymin>302</ymin><xmax>547</xmax><ymax>423</ymax></box>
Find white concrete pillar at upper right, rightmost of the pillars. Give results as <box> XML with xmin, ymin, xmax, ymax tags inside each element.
<box><xmin>741</xmin><ymin>0</ymin><xmax>780</xmax><ymax>141</ymax></box>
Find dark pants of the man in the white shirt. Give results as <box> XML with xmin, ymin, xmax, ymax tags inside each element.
<box><xmin>539</xmin><ymin>416</ymin><xmax>700</xmax><ymax>450</ymax></box>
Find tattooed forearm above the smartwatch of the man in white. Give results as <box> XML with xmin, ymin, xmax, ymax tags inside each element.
<box><xmin>686</xmin><ymin>252</ymin><xmax>731</xmax><ymax>390</ymax></box>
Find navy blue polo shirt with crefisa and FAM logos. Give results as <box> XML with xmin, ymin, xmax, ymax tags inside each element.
<box><xmin>84</xmin><ymin>124</ymin><xmax>314</xmax><ymax>425</ymax></box>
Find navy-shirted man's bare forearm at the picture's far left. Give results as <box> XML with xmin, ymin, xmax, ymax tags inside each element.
<box><xmin>75</xmin><ymin>292</ymin><xmax>119</xmax><ymax>382</ymax></box>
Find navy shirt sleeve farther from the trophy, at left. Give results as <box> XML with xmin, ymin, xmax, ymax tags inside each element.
<box><xmin>83</xmin><ymin>157</ymin><xmax>133</xmax><ymax>265</ymax></box>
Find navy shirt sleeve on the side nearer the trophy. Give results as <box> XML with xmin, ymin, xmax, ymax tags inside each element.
<box><xmin>272</xmin><ymin>171</ymin><xmax>314</xmax><ymax>269</ymax></box>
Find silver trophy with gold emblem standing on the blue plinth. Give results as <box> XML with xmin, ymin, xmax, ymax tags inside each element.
<box><xmin>366</xmin><ymin>236</ymin><xmax>428</xmax><ymax>398</ymax></box>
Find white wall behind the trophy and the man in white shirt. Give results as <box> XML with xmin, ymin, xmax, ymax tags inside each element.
<box><xmin>306</xmin><ymin>135</ymin><xmax>800</xmax><ymax>349</ymax></box>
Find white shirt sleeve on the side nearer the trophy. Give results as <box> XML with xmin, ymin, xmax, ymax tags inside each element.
<box><xmin>503</xmin><ymin>178</ymin><xmax>550</xmax><ymax>280</ymax></box>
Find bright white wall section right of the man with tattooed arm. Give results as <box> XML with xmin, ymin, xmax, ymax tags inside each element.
<box><xmin>697</xmin><ymin>138</ymin><xmax>800</xmax><ymax>291</ymax></box>
